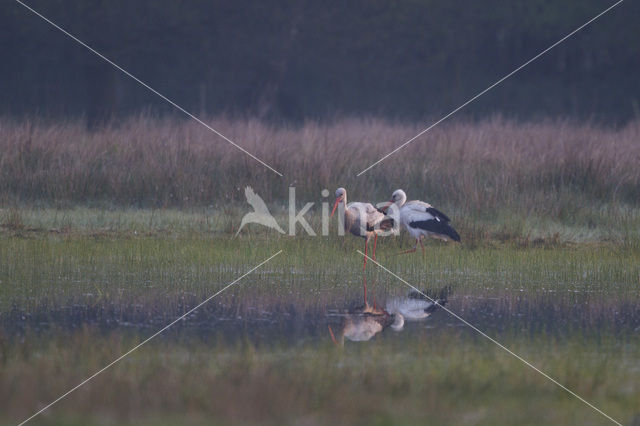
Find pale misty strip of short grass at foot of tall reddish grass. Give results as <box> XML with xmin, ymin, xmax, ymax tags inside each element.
<box><xmin>0</xmin><ymin>205</ymin><xmax>640</xmax><ymax>248</ymax></box>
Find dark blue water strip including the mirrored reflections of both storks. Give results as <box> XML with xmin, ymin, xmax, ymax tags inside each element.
<box><xmin>0</xmin><ymin>284</ymin><xmax>640</xmax><ymax>344</ymax></box>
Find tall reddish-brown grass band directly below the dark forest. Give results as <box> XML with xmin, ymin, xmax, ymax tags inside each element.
<box><xmin>0</xmin><ymin>116</ymin><xmax>640</xmax><ymax>215</ymax></box>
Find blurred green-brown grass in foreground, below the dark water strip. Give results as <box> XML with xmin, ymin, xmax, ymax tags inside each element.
<box><xmin>0</xmin><ymin>329</ymin><xmax>640</xmax><ymax>425</ymax></box>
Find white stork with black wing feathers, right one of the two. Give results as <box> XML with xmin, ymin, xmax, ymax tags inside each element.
<box><xmin>386</xmin><ymin>189</ymin><xmax>460</xmax><ymax>253</ymax></box>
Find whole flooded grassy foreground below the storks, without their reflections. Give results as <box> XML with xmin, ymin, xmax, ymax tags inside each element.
<box><xmin>0</xmin><ymin>228</ymin><xmax>640</xmax><ymax>424</ymax></box>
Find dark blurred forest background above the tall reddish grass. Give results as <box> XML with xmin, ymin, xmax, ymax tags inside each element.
<box><xmin>0</xmin><ymin>0</ymin><xmax>640</xmax><ymax>125</ymax></box>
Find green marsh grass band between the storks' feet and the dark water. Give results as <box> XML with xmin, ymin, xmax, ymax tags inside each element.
<box><xmin>0</xmin><ymin>220</ymin><xmax>640</xmax><ymax>310</ymax></box>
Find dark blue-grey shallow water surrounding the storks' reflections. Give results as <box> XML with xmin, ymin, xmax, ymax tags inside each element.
<box><xmin>6</xmin><ymin>282</ymin><xmax>640</xmax><ymax>342</ymax></box>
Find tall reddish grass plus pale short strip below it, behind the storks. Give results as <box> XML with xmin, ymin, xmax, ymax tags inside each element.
<box><xmin>5</xmin><ymin>116</ymin><xmax>640</xmax><ymax>247</ymax></box>
